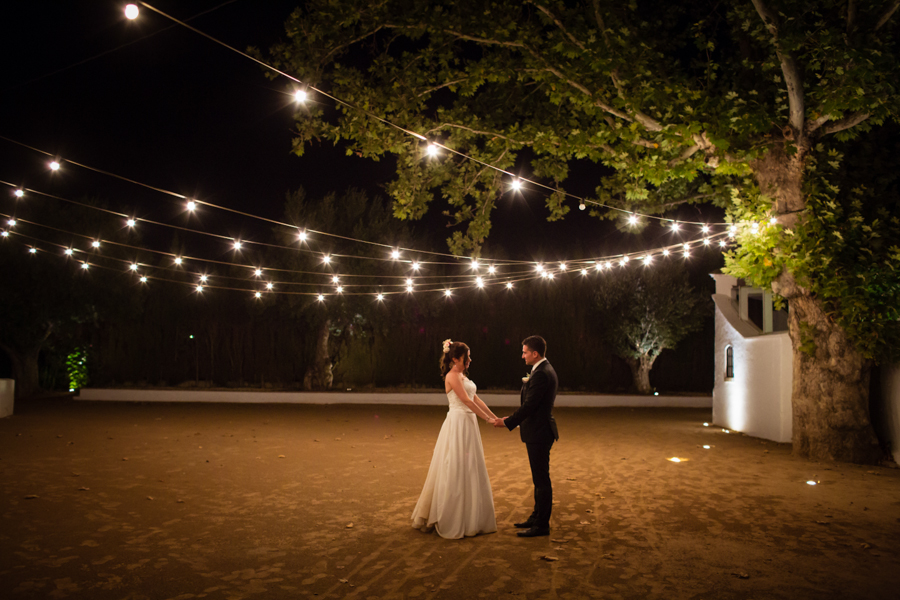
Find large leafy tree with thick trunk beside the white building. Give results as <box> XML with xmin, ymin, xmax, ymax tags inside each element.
<box><xmin>271</xmin><ymin>0</ymin><xmax>900</xmax><ymax>462</ymax></box>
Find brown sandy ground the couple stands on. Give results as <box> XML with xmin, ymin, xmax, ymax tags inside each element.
<box><xmin>0</xmin><ymin>400</ymin><xmax>900</xmax><ymax>600</ymax></box>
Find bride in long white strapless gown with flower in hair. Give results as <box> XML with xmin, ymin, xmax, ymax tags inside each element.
<box><xmin>413</xmin><ymin>340</ymin><xmax>497</xmax><ymax>539</ymax></box>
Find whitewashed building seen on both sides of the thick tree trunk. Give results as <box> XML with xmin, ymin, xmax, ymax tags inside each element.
<box><xmin>712</xmin><ymin>273</ymin><xmax>900</xmax><ymax>462</ymax></box>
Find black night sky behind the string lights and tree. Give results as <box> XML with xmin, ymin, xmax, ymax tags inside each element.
<box><xmin>0</xmin><ymin>0</ymin><xmax>721</xmax><ymax>268</ymax></box>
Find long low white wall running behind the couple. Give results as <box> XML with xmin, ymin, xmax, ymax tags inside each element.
<box><xmin>76</xmin><ymin>388</ymin><xmax>712</xmax><ymax>408</ymax></box>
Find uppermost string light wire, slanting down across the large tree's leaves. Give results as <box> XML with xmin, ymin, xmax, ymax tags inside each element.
<box><xmin>140</xmin><ymin>2</ymin><xmax>728</xmax><ymax>225</ymax></box>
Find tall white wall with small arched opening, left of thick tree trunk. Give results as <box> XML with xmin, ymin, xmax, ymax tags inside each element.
<box><xmin>712</xmin><ymin>294</ymin><xmax>793</xmax><ymax>442</ymax></box>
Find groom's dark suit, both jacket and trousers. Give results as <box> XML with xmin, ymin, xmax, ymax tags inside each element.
<box><xmin>504</xmin><ymin>360</ymin><xmax>559</xmax><ymax>527</ymax></box>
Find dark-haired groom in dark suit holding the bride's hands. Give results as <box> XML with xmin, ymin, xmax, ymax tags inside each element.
<box><xmin>494</xmin><ymin>335</ymin><xmax>559</xmax><ymax>537</ymax></box>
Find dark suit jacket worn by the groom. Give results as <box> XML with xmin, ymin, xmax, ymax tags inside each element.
<box><xmin>504</xmin><ymin>361</ymin><xmax>559</xmax><ymax>443</ymax></box>
